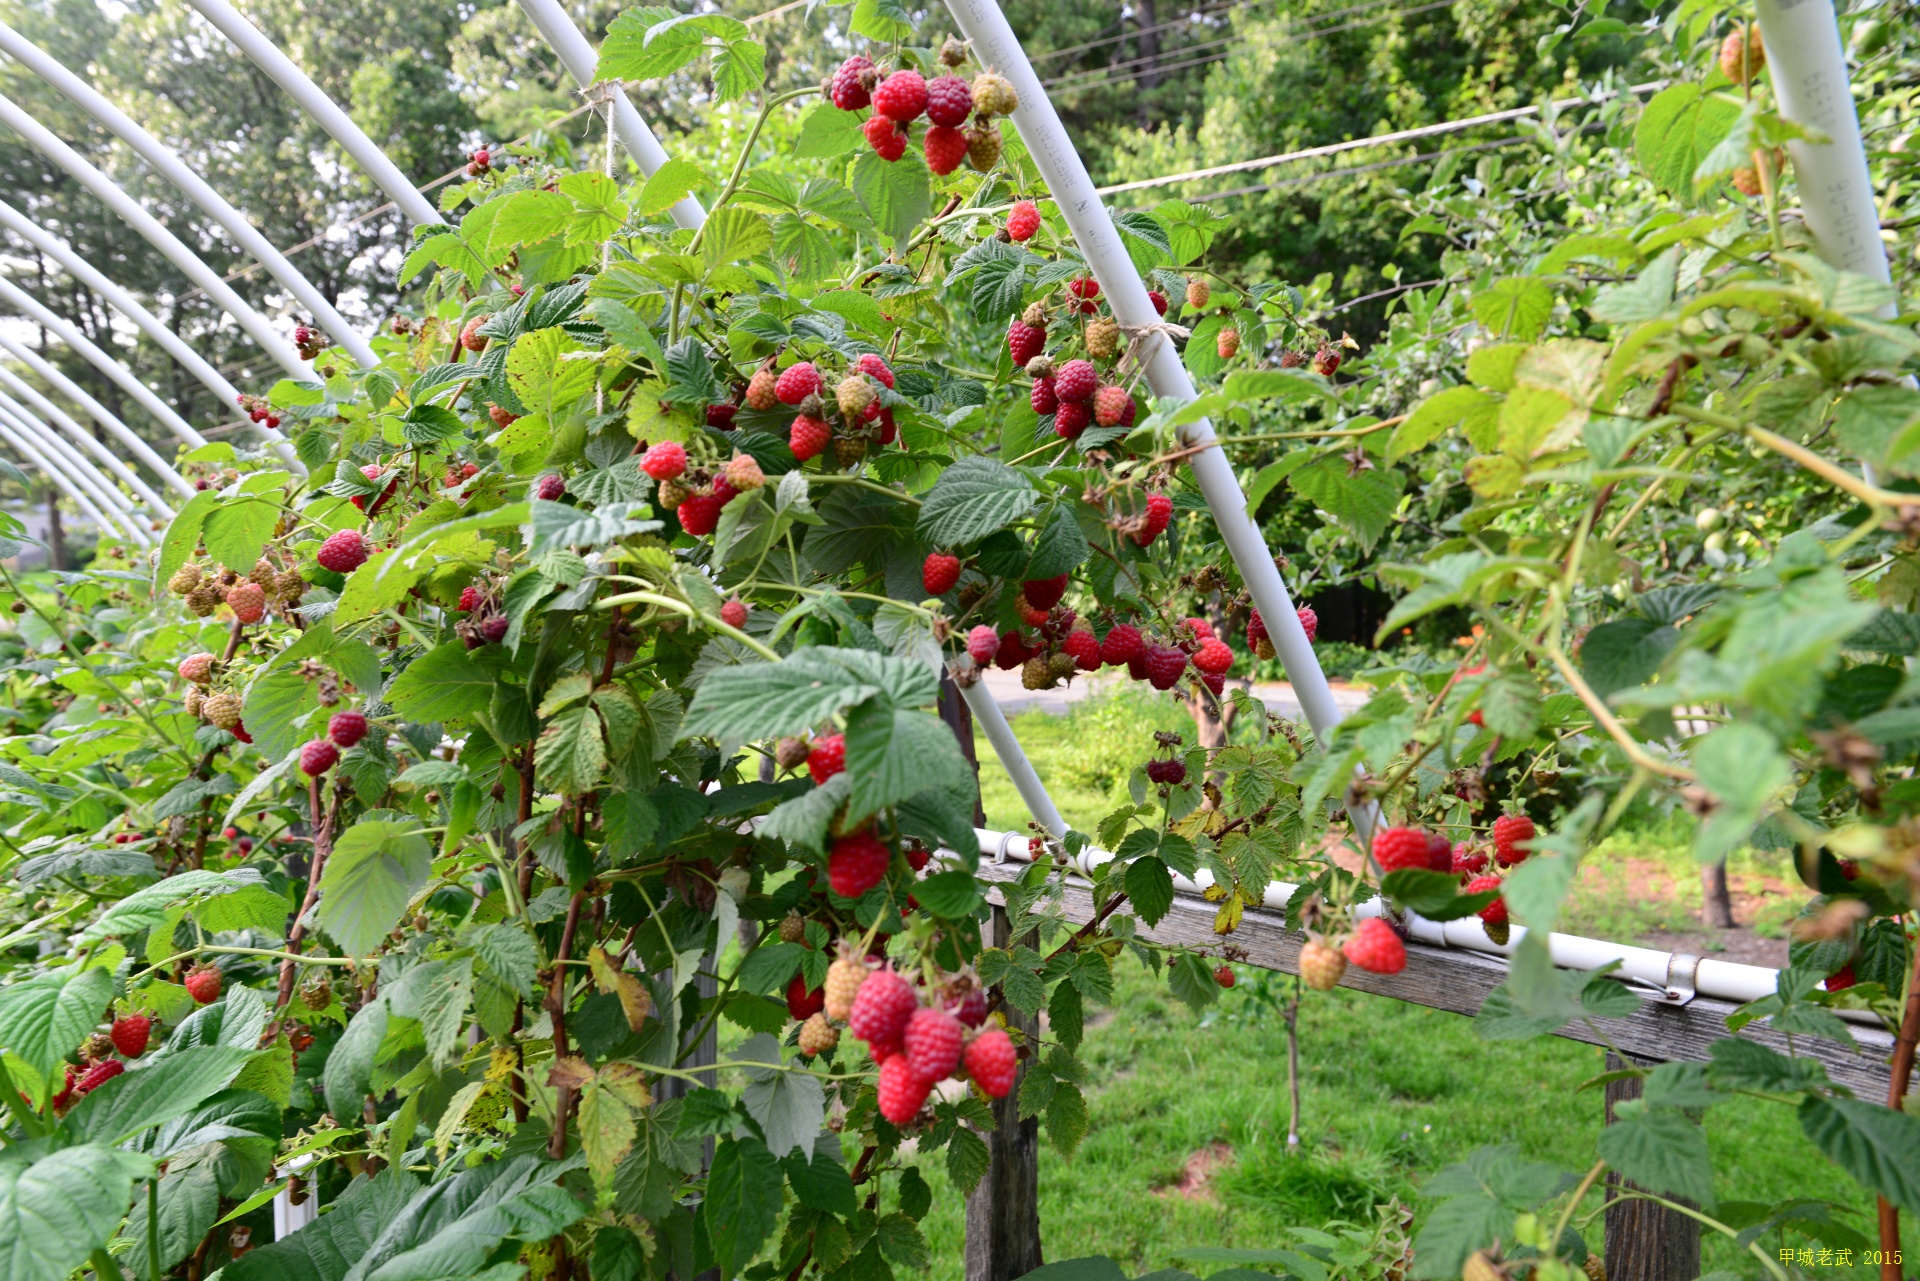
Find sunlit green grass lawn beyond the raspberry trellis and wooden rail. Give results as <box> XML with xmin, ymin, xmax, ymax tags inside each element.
<box><xmin>925</xmin><ymin>691</ymin><xmax>1872</xmax><ymax>1281</ymax></box>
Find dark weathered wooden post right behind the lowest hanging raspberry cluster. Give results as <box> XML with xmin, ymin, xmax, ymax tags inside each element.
<box><xmin>956</xmin><ymin>902</ymin><xmax>1044</xmax><ymax>1281</ymax></box>
